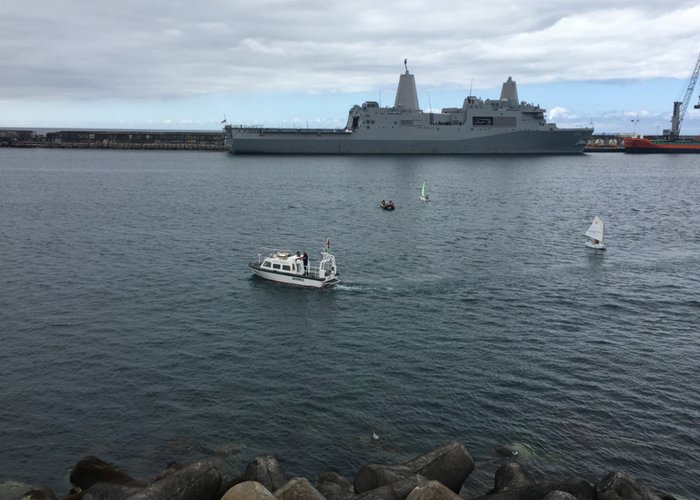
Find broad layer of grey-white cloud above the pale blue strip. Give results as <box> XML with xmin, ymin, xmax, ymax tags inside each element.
<box><xmin>0</xmin><ymin>0</ymin><xmax>700</xmax><ymax>100</ymax></box>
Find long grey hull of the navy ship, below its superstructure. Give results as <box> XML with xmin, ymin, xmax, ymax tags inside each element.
<box><xmin>226</xmin><ymin>126</ymin><xmax>592</xmax><ymax>155</ymax></box>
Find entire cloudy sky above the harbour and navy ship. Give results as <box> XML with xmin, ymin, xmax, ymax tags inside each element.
<box><xmin>0</xmin><ymin>0</ymin><xmax>700</xmax><ymax>134</ymax></box>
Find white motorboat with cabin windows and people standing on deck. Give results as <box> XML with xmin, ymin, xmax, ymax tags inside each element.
<box><xmin>248</xmin><ymin>240</ymin><xmax>340</xmax><ymax>288</ymax></box>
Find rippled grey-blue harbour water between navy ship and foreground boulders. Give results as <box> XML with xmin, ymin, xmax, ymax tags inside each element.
<box><xmin>0</xmin><ymin>149</ymin><xmax>700</xmax><ymax>499</ymax></box>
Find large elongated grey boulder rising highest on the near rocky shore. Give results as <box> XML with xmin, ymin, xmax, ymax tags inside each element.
<box><xmin>353</xmin><ymin>442</ymin><xmax>474</xmax><ymax>493</ymax></box>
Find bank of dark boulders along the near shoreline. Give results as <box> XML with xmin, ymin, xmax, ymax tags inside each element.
<box><xmin>15</xmin><ymin>442</ymin><xmax>676</xmax><ymax>500</ymax></box>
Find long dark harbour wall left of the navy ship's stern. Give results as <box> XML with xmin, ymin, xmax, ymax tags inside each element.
<box><xmin>0</xmin><ymin>129</ymin><xmax>226</xmax><ymax>151</ymax></box>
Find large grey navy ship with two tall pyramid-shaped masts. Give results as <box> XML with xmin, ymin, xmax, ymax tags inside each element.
<box><xmin>224</xmin><ymin>61</ymin><xmax>593</xmax><ymax>155</ymax></box>
